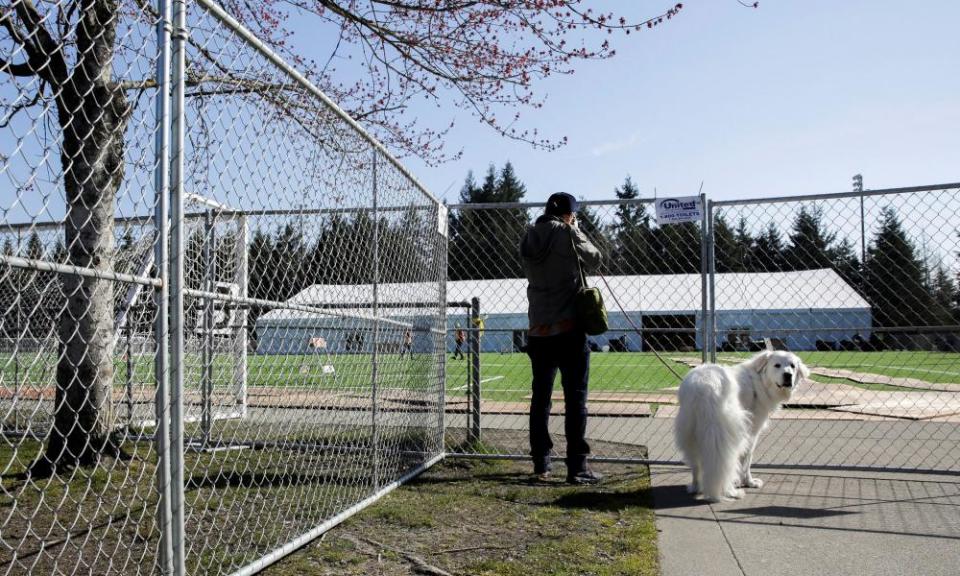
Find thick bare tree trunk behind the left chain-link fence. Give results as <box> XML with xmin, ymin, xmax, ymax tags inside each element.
<box><xmin>33</xmin><ymin>0</ymin><xmax>130</xmax><ymax>475</ymax></box>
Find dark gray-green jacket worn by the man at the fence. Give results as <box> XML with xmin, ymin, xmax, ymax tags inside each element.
<box><xmin>520</xmin><ymin>215</ymin><xmax>601</xmax><ymax>335</ymax></box>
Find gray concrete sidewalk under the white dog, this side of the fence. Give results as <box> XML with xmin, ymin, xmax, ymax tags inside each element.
<box><xmin>651</xmin><ymin>466</ymin><xmax>960</xmax><ymax>576</ymax></box>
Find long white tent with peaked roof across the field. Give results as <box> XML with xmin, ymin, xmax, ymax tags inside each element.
<box><xmin>257</xmin><ymin>269</ymin><xmax>871</xmax><ymax>353</ymax></box>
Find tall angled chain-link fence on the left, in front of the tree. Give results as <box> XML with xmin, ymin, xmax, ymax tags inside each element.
<box><xmin>0</xmin><ymin>0</ymin><xmax>447</xmax><ymax>574</ymax></box>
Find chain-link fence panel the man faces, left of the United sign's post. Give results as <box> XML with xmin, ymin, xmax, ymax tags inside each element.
<box><xmin>447</xmin><ymin>200</ymin><xmax>707</xmax><ymax>461</ymax></box>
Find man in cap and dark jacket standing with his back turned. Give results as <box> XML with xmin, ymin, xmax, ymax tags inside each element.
<box><xmin>520</xmin><ymin>192</ymin><xmax>602</xmax><ymax>484</ymax></box>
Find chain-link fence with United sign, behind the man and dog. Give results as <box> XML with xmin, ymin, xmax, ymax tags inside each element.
<box><xmin>447</xmin><ymin>184</ymin><xmax>960</xmax><ymax>471</ymax></box>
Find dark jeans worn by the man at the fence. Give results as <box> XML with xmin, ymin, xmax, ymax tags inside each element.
<box><xmin>527</xmin><ymin>332</ymin><xmax>590</xmax><ymax>474</ymax></box>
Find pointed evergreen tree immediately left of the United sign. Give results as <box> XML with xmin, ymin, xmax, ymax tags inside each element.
<box><xmin>610</xmin><ymin>176</ymin><xmax>656</xmax><ymax>274</ymax></box>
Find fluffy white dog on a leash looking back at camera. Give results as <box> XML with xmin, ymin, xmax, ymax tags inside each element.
<box><xmin>674</xmin><ymin>352</ymin><xmax>810</xmax><ymax>502</ymax></box>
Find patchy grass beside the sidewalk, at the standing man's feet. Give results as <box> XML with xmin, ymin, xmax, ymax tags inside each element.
<box><xmin>265</xmin><ymin>460</ymin><xmax>658</xmax><ymax>576</ymax></box>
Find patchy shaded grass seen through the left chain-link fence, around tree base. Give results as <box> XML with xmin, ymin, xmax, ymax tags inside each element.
<box><xmin>0</xmin><ymin>422</ymin><xmax>422</xmax><ymax>574</ymax></box>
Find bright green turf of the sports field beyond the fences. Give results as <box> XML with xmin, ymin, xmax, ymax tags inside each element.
<box><xmin>7</xmin><ymin>351</ymin><xmax>960</xmax><ymax>401</ymax></box>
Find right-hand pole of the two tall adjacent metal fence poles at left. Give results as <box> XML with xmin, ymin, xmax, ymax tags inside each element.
<box><xmin>170</xmin><ymin>0</ymin><xmax>187</xmax><ymax>576</ymax></box>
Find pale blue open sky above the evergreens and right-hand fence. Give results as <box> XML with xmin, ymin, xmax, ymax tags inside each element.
<box><xmin>295</xmin><ymin>0</ymin><xmax>960</xmax><ymax>202</ymax></box>
